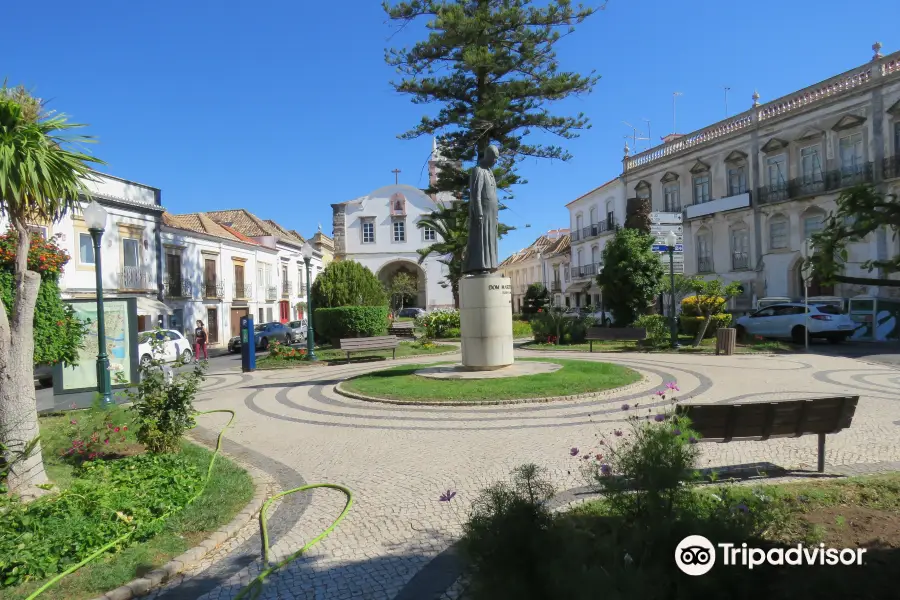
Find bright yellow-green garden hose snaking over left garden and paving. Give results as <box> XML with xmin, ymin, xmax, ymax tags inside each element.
<box><xmin>26</xmin><ymin>409</ymin><xmax>353</xmax><ymax>600</ymax></box>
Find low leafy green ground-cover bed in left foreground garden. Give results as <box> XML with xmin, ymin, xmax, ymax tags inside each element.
<box><xmin>0</xmin><ymin>454</ymin><xmax>202</xmax><ymax>587</ymax></box>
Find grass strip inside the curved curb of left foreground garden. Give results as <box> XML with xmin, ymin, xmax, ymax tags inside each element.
<box><xmin>0</xmin><ymin>413</ymin><xmax>254</xmax><ymax>600</ymax></box>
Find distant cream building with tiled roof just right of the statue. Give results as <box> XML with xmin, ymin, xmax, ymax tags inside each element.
<box><xmin>498</xmin><ymin>229</ymin><xmax>569</xmax><ymax>313</ymax></box>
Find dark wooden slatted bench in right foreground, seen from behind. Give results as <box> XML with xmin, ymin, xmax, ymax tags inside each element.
<box><xmin>676</xmin><ymin>396</ymin><xmax>859</xmax><ymax>473</ymax></box>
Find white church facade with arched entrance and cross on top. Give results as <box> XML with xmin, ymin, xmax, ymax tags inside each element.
<box><xmin>331</xmin><ymin>184</ymin><xmax>453</xmax><ymax>310</ymax></box>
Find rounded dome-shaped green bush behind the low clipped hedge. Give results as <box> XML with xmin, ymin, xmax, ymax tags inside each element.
<box><xmin>312</xmin><ymin>260</ymin><xmax>388</xmax><ymax>308</ymax></box>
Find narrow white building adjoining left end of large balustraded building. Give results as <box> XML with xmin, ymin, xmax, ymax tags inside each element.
<box><xmin>566</xmin><ymin>177</ymin><xmax>625</xmax><ymax>306</ymax></box>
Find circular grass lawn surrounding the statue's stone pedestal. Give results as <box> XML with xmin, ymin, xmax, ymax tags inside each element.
<box><xmin>343</xmin><ymin>359</ymin><xmax>641</xmax><ymax>402</ymax></box>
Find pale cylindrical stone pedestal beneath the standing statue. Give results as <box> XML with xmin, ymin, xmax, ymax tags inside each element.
<box><xmin>459</xmin><ymin>274</ymin><xmax>513</xmax><ymax>371</ymax></box>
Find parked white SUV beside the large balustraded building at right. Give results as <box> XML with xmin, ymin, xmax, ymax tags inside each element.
<box><xmin>735</xmin><ymin>302</ymin><xmax>856</xmax><ymax>344</ymax></box>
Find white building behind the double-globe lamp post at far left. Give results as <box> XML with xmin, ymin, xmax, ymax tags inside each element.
<box><xmin>0</xmin><ymin>172</ymin><xmax>168</xmax><ymax>330</ymax></box>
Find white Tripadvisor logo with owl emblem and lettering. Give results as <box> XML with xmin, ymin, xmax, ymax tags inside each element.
<box><xmin>675</xmin><ymin>535</ymin><xmax>866</xmax><ymax>576</ymax></box>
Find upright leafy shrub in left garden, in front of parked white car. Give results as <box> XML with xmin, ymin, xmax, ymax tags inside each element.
<box><xmin>128</xmin><ymin>336</ymin><xmax>205</xmax><ymax>453</ymax></box>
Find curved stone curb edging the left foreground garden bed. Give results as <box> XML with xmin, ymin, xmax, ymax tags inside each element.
<box><xmin>94</xmin><ymin>437</ymin><xmax>270</xmax><ymax>600</ymax></box>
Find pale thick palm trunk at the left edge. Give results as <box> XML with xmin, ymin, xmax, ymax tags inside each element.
<box><xmin>0</xmin><ymin>225</ymin><xmax>47</xmax><ymax>492</ymax></box>
